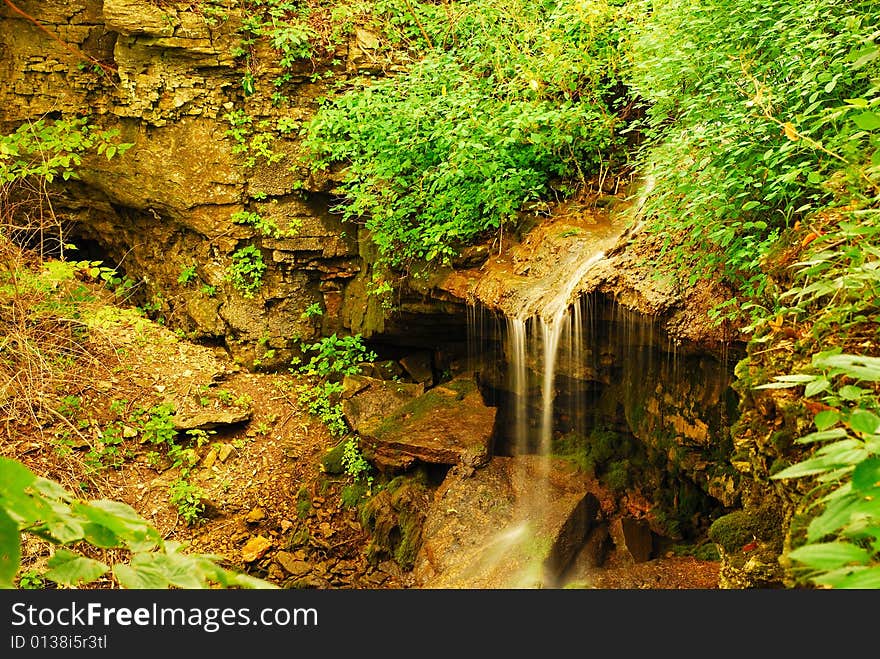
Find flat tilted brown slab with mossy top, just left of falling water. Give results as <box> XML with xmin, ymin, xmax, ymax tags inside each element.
<box><xmin>359</xmin><ymin>377</ymin><xmax>497</xmax><ymax>469</ymax></box>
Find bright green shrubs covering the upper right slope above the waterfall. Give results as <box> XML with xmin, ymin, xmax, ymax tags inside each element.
<box><xmin>628</xmin><ymin>0</ymin><xmax>880</xmax><ymax>302</ymax></box>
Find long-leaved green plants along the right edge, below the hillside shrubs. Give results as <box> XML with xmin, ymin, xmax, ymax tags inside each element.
<box><xmin>754</xmin><ymin>208</ymin><xmax>880</xmax><ymax>588</ymax></box>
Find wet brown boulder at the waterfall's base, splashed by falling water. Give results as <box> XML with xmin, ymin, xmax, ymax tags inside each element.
<box><xmin>413</xmin><ymin>456</ymin><xmax>599</xmax><ymax>589</ymax></box>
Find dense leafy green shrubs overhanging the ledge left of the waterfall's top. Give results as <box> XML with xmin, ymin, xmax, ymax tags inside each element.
<box><xmin>308</xmin><ymin>0</ymin><xmax>624</xmax><ymax>265</ymax></box>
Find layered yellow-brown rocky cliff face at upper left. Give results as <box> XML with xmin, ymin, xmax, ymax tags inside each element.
<box><xmin>0</xmin><ymin>0</ymin><xmax>396</xmax><ymax>366</ymax></box>
